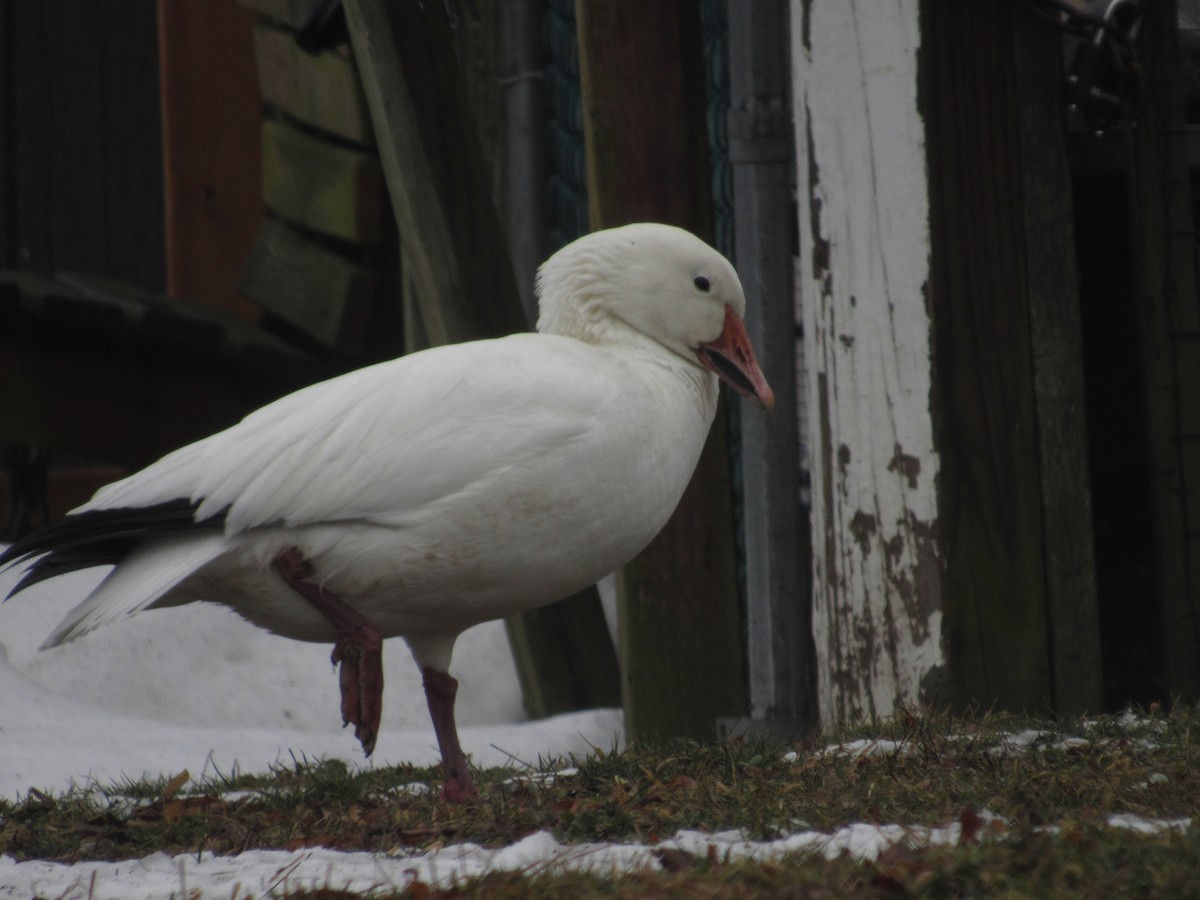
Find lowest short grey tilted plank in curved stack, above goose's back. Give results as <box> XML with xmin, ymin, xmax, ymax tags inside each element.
<box><xmin>238</xmin><ymin>218</ymin><xmax>378</xmax><ymax>356</ymax></box>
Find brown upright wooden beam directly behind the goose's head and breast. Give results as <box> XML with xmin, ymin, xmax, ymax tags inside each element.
<box><xmin>576</xmin><ymin>0</ymin><xmax>746</xmax><ymax>742</ymax></box>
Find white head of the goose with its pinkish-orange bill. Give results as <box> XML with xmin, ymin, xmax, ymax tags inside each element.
<box><xmin>538</xmin><ymin>222</ymin><xmax>775</xmax><ymax>409</ymax></box>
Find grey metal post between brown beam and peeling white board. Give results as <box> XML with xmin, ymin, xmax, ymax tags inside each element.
<box><xmin>728</xmin><ymin>0</ymin><xmax>817</xmax><ymax>733</ymax></box>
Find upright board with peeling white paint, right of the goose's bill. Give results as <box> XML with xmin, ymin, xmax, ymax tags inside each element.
<box><xmin>792</xmin><ymin>0</ymin><xmax>944</xmax><ymax>725</ymax></box>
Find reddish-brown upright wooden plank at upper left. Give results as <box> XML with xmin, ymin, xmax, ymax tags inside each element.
<box><xmin>158</xmin><ymin>0</ymin><xmax>263</xmax><ymax>320</ymax></box>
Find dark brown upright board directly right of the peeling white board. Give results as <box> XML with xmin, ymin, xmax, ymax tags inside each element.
<box><xmin>922</xmin><ymin>0</ymin><xmax>1054</xmax><ymax>709</ymax></box>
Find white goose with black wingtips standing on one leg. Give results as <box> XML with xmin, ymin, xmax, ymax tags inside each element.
<box><xmin>0</xmin><ymin>224</ymin><xmax>774</xmax><ymax>799</ymax></box>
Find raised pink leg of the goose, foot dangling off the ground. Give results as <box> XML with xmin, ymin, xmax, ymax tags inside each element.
<box><xmin>275</xmin><ymin>547</ymin><xmax>383</xmax><ymax>756</ymax></box>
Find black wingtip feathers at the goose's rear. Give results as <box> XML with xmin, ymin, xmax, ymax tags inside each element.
<box><xmin>0</xmin><ymin>498</ymin><xmax>226</xmax><ymax>596</ymax></box>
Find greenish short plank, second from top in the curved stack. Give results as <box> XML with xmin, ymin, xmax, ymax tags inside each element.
<box><xmin>254</xmin><ymin>23</ymin><xmax>374</xmax><ymax>145</ymax></box>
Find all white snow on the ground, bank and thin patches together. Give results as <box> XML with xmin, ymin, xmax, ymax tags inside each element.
<box><xmin>0</xmin><ymin>561</ymin><xmax>1190</xmax><ymax>900</ymax></box>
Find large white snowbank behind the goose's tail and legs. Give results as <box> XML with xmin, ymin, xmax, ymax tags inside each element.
<box><xmin>0</xmin><ymin>570</ymin><xmax>622</xmax><ymax>797</ymax></box>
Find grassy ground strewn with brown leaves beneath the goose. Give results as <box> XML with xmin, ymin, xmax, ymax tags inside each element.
<box><xmin>0</xmin><ymin>704</ymin><xmax>1200</xmax><ymax>898</ymax></box>
